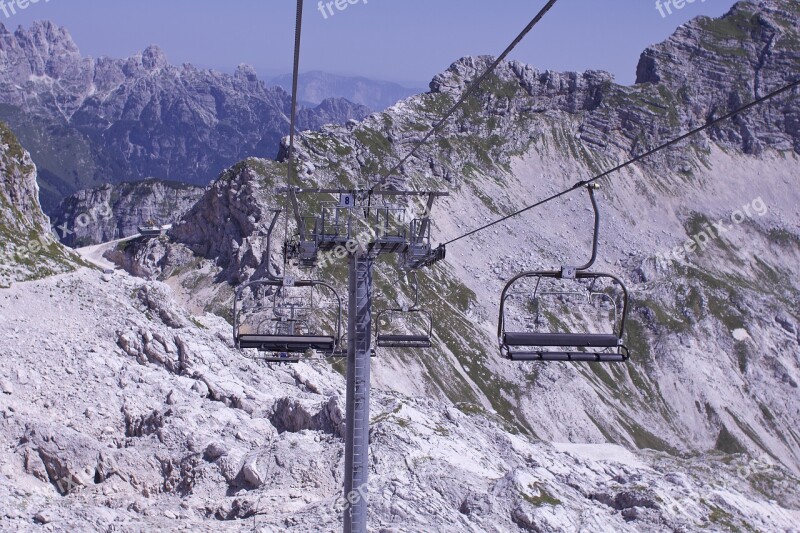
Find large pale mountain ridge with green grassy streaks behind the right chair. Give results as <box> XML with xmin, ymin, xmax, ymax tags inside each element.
<box><xmin>114</xmin><ymin>0</ymin><xmax>800</xmax><ymax>478</ymax></box>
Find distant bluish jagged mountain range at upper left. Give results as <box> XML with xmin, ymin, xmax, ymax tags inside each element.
<box><xmin>0</xmin><ymin>22</ymin><xmax>369</xmax><ymax>212</ymax></box>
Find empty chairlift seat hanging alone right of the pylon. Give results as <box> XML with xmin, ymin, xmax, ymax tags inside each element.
<box><xmin>497</xmin><ymin>184</ymin><xmax>629</xmax><ymax>363</ymax></box>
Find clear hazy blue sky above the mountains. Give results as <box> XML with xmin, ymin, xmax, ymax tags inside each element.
<box><xmin>0</xmin><ymin>0</ymin><xmax>734</xmax><ymax>86</ymax></box>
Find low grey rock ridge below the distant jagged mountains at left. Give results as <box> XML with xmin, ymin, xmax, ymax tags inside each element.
<box><xmin>53</xmin><ymin>179</ymin><xmax>203</xmax><ymax>248</ymax></box>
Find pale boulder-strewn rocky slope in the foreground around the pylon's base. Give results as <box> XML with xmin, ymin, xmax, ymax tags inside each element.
<box><xmin>0</xmin><ymin>130</ymin><xmax>800</xmax><ymax>532</ymax></box>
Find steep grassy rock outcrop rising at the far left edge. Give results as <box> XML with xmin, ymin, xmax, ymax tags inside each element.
<box><xmin>0</xmin><ymin>122</ymin><xmax>76</xmax><ymax>287</ymax></box>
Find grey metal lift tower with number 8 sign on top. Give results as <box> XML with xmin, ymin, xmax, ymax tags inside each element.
<box><xmin>281</xmin><ymin>188</ymin><xmax>448</xmax><ymax>533</ymax></box>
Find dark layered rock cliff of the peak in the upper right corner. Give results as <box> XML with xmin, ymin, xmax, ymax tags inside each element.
<box><xmin>637</xmin><ymin>0</ymin><xmax>800</xmax><ymax>153</ymax></box>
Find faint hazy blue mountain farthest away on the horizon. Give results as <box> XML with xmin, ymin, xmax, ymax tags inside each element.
<box><xmin>270</xmin><ymin>70</ymin><xmax>425</xmax><ymax>111</ymax></box>
